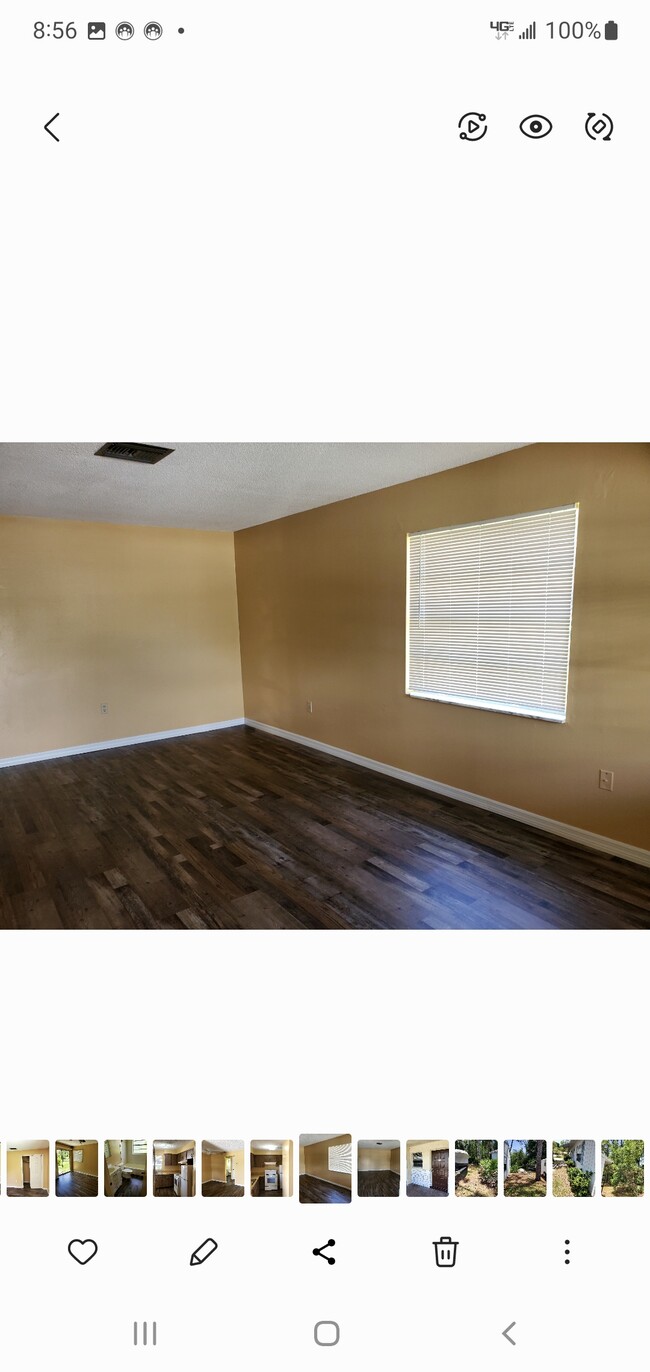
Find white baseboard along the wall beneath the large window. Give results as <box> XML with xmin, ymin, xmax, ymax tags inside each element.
<box><xmin>244</xmin><ymin>719</ymin><xmax>650</xmax><ymax>867</ymax></box>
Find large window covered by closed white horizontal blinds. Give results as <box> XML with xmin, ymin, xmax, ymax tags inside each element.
<box><xmin>406</xmin><ymin>505</ymin><xmax>577</xmax><ymax>723</ymax></box>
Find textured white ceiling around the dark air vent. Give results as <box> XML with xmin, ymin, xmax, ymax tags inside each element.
<box><xmin>0</xmin><ymin>444</ymin><xmax>525</xmax><ymax>530</ymax></box>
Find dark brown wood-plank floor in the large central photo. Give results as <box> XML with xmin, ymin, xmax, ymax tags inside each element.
<box><xmin>0</xmin><ymin>726</ymin><xmax>650</xmax><ymax>929</ymax></box>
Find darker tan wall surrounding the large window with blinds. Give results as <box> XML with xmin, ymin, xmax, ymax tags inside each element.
<box><xmin>234</xmin><ymin>443</ymin><xmax>650</xmax><ymax>847</ymax></box>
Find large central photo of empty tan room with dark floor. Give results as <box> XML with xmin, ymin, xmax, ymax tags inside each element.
<box><xmin>0</xmin><ymin>443</ymin><xmax>650</xmax><ymax>932</ymax></box>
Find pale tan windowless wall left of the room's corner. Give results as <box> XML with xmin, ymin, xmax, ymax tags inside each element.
<box><xmin>0</xmin><ymin>517</ymin><xmax>243</xmax><ymax>757</ymax></box>
